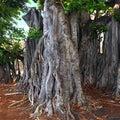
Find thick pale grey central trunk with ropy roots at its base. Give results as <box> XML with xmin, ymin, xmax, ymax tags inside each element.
<box><xmin>19</xmin><ymin>0</ymin><xmax>85</xmax><ymax>119</ymax></box>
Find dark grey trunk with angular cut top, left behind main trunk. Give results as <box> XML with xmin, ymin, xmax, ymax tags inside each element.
<box><xmin>17</xmin><ymin>8</ymin><xmax>42</xmax><ymax>90</ymax></box>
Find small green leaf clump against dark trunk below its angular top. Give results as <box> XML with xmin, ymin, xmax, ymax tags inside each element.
<box><xmin>28</xmin><ymin>27</ymin><xmax>42</xmax><ymax>40</ymax></box>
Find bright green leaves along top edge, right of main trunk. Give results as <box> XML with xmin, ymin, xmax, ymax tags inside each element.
<box><xmin>64</xmin><ymin>0</ymin><xmax>107</xmax><ymax>13</ymax></box>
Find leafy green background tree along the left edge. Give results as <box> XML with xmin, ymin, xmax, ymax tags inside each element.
<box><xmin>0</xmin><ymin>0</ymin><xmax>27</xmax><ymax>83</ymax></box>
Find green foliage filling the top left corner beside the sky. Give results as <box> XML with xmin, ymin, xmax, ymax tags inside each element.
<box><xmin>0</xmin><ymin>0</ymin><xmax>27</xmax><ymax>39</ymax></box>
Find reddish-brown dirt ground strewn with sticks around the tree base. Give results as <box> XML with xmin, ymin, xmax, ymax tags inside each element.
<box><xmin>0</xmin><ymin>84</ymin><xmax>120</xmax><ymax>120</ymax></box>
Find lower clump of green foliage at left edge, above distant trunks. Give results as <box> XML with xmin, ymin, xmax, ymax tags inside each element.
<box><xmin>0</xmin><ymin>32</ymin><xmax>24</xmax><ymax>64</ymax></box>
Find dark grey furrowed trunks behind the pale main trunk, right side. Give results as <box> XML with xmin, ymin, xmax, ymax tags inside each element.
<box><xmin>79</xmin><ymin>17</ymin><xmax>120</xmax><ymax>96</ymax></box>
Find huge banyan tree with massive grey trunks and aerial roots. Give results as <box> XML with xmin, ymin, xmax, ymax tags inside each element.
<box><xmin>20</xmin><ymin>0</ymin><xmax>120</xmax><ymax>119</ymax></box>
